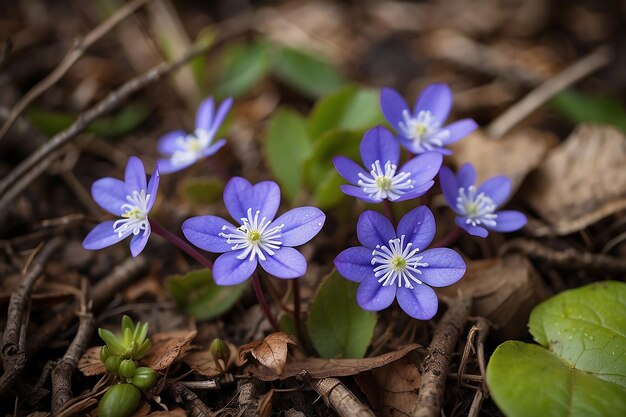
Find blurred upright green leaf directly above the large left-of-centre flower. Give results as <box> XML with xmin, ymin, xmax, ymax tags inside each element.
<box><xmin>264</xmin><ymin>109</ymin><xmax>311</xmax><ymax>200</ymax></box>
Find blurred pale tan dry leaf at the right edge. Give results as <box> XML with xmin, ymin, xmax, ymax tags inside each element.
<box><xmin>527</xmin><ymin>124</ymin><xmax>626</xmax><ymax>235</ymax></box>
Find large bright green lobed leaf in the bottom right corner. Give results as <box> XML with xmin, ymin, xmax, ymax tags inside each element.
<box><xmin>487</xmin><ymin>281</ymin><xmax>626</xmax><ymax>417</ymax></box>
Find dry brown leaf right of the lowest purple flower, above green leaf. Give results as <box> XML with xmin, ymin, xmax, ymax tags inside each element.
<box><xmin>436</xmin><ymin>254</ymin><xmax>550</xmax><ymax>340</ymax></box>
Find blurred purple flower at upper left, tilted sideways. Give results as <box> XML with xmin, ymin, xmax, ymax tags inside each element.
<box><xmin>158</xmin><ymin>97</ymin><xmax>233</xmax><ymax>174</ymax></box>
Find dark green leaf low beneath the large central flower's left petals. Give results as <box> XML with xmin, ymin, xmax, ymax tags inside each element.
<box><xmin>166</xmin><ymin>269</ymin><xmax>247</xmax><ymax>320</ymax></box>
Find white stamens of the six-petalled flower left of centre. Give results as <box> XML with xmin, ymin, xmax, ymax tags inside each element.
<box><xmin>219</xmin><ymin>208</ymin><xmax>285</xmax><ymax>261</ymax></box>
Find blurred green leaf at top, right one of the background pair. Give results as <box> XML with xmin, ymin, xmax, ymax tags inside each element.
<box><xmin>275</xmin><ymin>48</ymin><xmax>345</xmax><ymax>98</ymax></box>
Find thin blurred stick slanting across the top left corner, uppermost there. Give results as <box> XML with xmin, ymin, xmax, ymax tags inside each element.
<box><xmin>0</xmin><ymin>0</ymin><xmax>150</xmax><ymax>140</ymax></box>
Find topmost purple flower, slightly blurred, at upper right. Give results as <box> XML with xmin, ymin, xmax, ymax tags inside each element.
<box><xmin>380</xmin><ymin>84</ymin><xmax>478</xmax><ymax>155</ymax></box>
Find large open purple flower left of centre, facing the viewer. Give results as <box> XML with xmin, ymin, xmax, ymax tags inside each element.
<box><xmin>182</xmin><ymin>177</ymin><xmax>326</xmax><ymax>285</ymax></box>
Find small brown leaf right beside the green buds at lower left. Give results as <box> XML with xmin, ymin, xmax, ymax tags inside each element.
<box><xmin>141</xmin><ymin>330</ymin><xmax>197</xmax><ymax>371</ymax></box>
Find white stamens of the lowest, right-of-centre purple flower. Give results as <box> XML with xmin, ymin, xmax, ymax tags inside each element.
<box><xmin>372</xmin><ymin>235</ymin><xmax>428</xmax><ymax>289</ymax></box>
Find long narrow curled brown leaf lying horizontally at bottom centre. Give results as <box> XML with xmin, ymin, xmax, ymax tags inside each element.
<box><xmin>248</xmin><ymin>344</ymin><xmax>424</xmax><ymax>381</ymax></box>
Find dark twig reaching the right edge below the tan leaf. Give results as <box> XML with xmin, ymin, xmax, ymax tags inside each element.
<box><xmin>499</xmin><ymin>238</ymin><xmax>626</xmax><ymax>273</ymax></box>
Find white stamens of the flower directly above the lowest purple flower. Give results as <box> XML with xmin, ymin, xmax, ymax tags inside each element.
<box><xmin>358</xmin><ymin>159</ymin><xmax>415</xmax><ymax>201</ymax></box>
